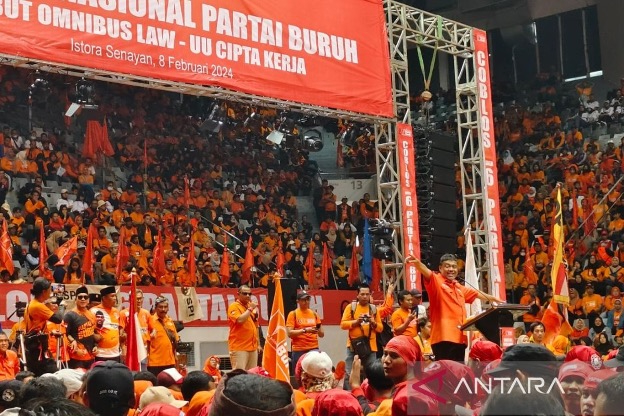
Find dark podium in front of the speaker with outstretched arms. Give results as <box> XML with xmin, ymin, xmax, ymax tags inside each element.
<box><xmin>460</xmin><ymin>304</ymin><xmax>531</xmax><ymax>345</ymax></box>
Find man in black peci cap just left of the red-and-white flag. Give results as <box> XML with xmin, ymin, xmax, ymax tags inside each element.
<box><xmin>91</xmin><ymin>286</ymin><xmax>121</xmax><ymax>362</ymax></box>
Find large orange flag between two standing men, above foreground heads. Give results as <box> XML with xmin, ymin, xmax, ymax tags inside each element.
<box><xmin>262</xmin><ymin>279</ymin><xmax>290</xmax><ymax>383</ymax></box>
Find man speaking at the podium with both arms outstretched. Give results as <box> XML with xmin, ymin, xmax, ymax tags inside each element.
<box><xmin>406</xmin><ymin>254</ymin><xmax>502</xmax><ymax>362</ymax></box>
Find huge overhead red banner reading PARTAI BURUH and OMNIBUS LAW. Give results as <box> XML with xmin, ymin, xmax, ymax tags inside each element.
<box><xmin>0</xmin><ymin>0</ymin><xmax>392</xmax><ymax>117</ymax></box>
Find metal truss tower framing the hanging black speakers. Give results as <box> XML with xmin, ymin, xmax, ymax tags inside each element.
<box><xmin>375</xmin><ymin>0</ymin><xmax>492</xmax><ymax>293</ymax></box>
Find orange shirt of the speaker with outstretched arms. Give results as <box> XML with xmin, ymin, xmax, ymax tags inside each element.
<box><xmin>425</xmin><ymin>272</ymin><xmax>479</xmax><ymax>345</ymax></box>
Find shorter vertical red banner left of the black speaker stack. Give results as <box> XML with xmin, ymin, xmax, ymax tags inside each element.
<box><xmin>397</xmin><ymin>123</ymin><xmax>421</xmax><ymax>290</ymax></box>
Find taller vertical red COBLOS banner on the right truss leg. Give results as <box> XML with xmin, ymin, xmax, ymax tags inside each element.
<box><xmin>474</xmin><ymin>29</ymin><xmax>505</xmax><ymax>300</ymax></box>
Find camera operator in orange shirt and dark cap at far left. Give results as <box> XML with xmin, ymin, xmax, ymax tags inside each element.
<box><xmin>24</xmin><ymin>277</ymin><xmax>63</xmax><ymax>377</ymax></box>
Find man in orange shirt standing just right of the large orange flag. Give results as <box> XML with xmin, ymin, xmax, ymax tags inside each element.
<box><xmin>286</xmin><ymin>291</ymin><xmax>325</xmax><ymax>374</ymax></box>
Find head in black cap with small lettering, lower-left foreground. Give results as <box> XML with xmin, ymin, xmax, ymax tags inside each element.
<box><xmin>83</xmin><ymin>361</ymin><xmax>135</xmax><ymax>416</ymax></box>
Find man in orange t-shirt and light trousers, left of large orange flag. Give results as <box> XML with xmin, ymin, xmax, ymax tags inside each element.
<box><xmin>228</xmin><ymin>285</ymin><xmax>259</xmax><ymax>370</ymax></box>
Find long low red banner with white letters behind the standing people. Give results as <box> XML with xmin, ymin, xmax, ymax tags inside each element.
<box><xmin>0</xmin><ymin>284</ymin><xmax>383</xmax><ymax>329</ymax></box>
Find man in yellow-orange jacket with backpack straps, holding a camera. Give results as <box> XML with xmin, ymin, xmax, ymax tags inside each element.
<box><xmin>340</xmin><ymin>284</ymin><xmax>383</xmax><ymax>390</ymax></box>
